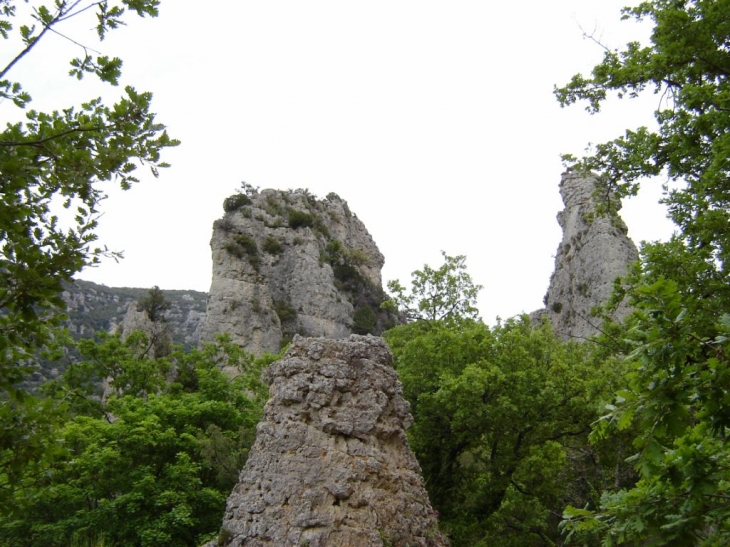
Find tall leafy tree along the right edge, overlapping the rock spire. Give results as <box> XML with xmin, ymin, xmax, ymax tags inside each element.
<box><xmin>556</xmin><ymin>0</ymin><xmax>730</xmax><ymax>545</ymax></box>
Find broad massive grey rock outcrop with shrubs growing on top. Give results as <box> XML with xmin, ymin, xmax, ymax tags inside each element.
<box><xmin>202</xmin><ymin>190</ymin><xmax>387</xmax><ymax>354</ymax></box>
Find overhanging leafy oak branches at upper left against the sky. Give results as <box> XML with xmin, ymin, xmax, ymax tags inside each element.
<box><xmin>0</xmin><ymin>0</ymin><xmax>178</xmax><ymax>391</ymax></box>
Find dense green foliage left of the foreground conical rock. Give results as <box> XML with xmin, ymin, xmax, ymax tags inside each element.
<box><xmin>0</xmin><ymin>333</ymin><xmax>272</xmax><ymax>546</ymax></box>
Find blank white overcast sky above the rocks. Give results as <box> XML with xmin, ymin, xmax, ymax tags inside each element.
<box><xmin>7</xmin><ymin>0</ymin><xmax>672</xmax><ymax>322</ymax></box>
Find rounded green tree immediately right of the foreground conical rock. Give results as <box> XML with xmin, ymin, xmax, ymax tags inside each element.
<box><xmin>385</xmin><ymin>317</ymin><xmax>618</xmax><ymax>547</ymax></box>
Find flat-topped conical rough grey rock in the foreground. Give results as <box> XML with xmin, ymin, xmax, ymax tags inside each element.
<box><xmin>209</xmin><ymin>335</ymin><xmax>448</xmax><ymax>547</ymax></box>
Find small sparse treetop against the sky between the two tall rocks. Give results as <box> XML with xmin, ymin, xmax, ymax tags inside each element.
<box><xmin>385</xmin><ymin>251</ymin><xmax>483</xmax><ymax>321</ymax></box>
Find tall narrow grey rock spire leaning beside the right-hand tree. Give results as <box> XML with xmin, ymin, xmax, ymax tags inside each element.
<box><xmin>533</xmin><ymin>171</ymin><xmax>639</xmax><ymax>340</ymax></box>
